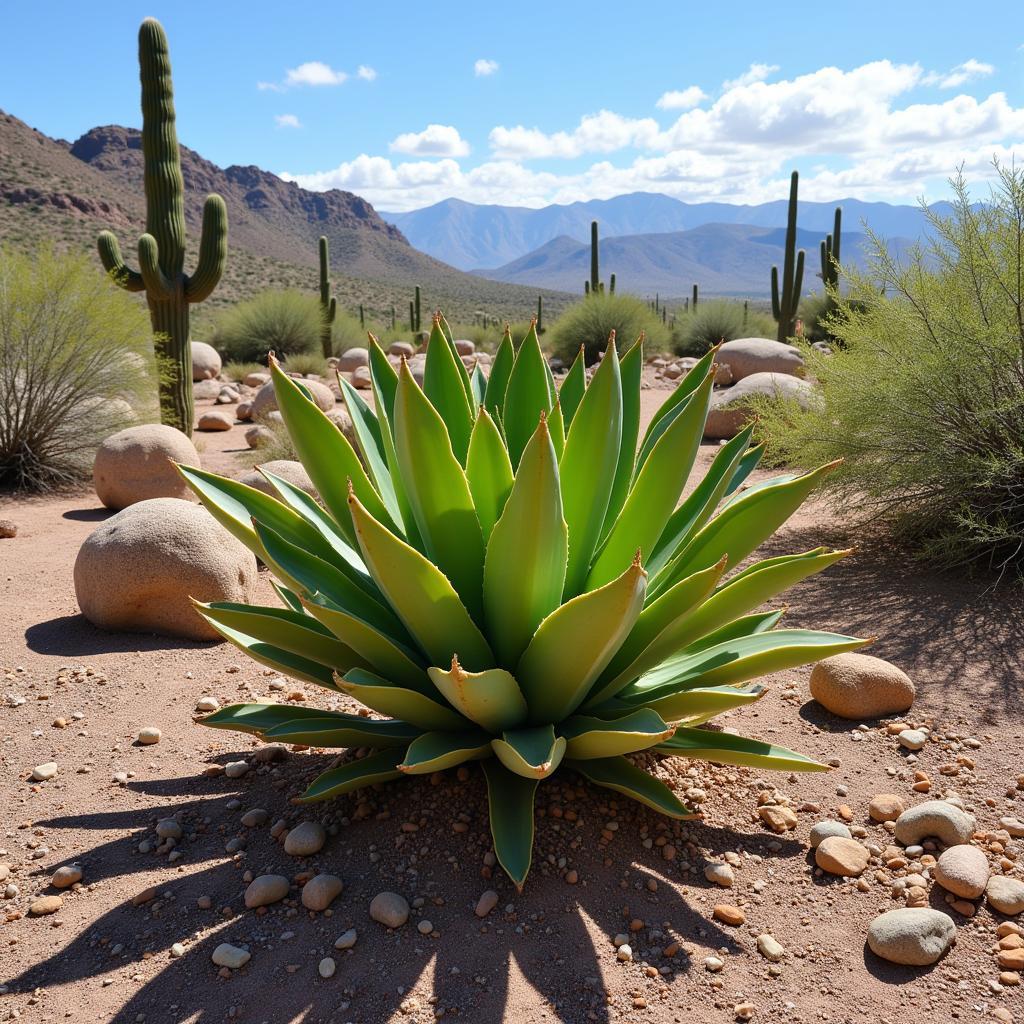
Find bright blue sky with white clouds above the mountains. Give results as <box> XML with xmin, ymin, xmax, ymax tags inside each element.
<box><xmin>0</xmin><ymin>0</ymin><xmax>1024</xmax><ymax>210</ymax></box>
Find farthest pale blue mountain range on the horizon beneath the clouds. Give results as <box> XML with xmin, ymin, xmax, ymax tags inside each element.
<box><xmin>381</xmin><ymin>193</ymin><xmax>949</xmax><ymax>270</ymax></box>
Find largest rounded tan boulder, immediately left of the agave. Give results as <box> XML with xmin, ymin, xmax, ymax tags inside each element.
<box><xmin>75</xmin><ymin>498</ymin><xmax>257</xmax><ymax>640</ymax></box>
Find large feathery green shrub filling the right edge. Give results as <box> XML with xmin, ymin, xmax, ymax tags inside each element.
<box><xmin>760</xmin><ymin>168</ymin><xmax>1024</xmax><ymax>573</ymax></box>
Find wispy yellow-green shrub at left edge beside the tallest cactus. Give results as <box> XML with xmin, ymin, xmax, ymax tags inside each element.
<box><xmin>0</xmin><ymin>247</ymin><xmax>157</xmax><ymax>489</ymax></box>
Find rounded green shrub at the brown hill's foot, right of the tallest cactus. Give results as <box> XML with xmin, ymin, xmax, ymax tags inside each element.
<box><xmin>210</xmin><ymin>291</ymin><xmax>322</xmax><ymax>362</ymax></box>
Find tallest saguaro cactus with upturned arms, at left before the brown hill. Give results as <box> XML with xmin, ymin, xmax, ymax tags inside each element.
<box><xmin>96</xmin><ymin>17</ymin><xmax>227</xmax><ymax>434</ymax></box>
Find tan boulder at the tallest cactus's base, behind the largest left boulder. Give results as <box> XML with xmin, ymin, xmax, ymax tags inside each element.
<box><xmin>92</xmin><ymin>423</ymin><xmax>200</xmax><ymax>510</ymax></box>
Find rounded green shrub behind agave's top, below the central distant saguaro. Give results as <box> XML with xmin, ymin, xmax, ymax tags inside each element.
<box><xmin>548</xmin><ymin>292</ymin><xmax>669</xmax><ymax>364</ymax></box>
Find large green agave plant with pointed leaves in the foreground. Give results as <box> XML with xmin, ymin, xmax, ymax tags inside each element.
<box><xmin>180</xmin><ymin>316</ymin><xmax>866</xmax><ymax>887</ymax></box>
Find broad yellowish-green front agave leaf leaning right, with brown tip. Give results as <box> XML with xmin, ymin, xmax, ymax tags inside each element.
<box><xmin>515</xmin><ymin>561</ymin><xmax>647</xmax><ymax>722</ymax></box>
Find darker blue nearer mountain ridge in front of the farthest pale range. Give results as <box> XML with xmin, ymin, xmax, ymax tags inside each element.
<box><xmin>475</xmin><ymin>224</ymin><xmax>911</xmax><ymax>298</ymax></box>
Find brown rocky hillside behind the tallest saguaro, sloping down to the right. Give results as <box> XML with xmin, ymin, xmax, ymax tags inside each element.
<box><xmin>0</xmin><ymin>111</ymin><xmax>569</xmax><ymax>330</ymax></box>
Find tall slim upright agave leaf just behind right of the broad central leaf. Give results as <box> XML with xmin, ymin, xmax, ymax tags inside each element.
<box><xmin>558</xmin><ymin>341</ymin><xmax>623</xmax><ymax>599</ymax></box>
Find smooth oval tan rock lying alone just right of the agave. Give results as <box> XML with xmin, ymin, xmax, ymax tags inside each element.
<box><xmin>811</xmin><ymin>651</ymin><xmax>914</xmax><ymax>721</ymax></box>
